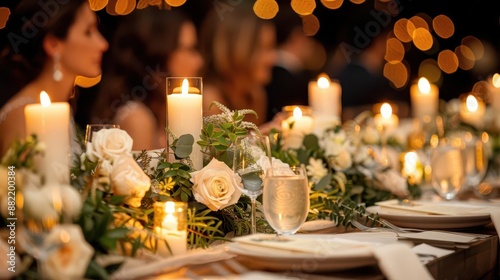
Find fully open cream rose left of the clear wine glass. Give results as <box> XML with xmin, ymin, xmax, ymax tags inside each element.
<box><xmin>191</xmin><ymin>158</ymin><xmax>241</xmax><ymax>211</ymax></box>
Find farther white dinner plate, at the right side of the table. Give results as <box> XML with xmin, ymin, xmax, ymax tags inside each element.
<box><xmin>366</xmin><ymin>206</ymin><xmax>491</xmax><ymax>229</ymax></box>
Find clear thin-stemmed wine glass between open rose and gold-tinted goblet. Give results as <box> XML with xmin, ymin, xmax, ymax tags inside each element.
<box><xmin>233</xmin><ymin>134</ymin><xmax>271</xmax><ymax>234</ymax></box>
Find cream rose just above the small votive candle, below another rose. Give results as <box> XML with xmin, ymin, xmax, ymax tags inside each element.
<box><xmin>111</xmin><ymin>155</ymin><xmax>151</xmax><ymax>207</ymax></box>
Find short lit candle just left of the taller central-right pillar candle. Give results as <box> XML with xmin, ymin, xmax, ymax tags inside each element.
<box><xmin>281</xmin><ymin>106</ymin><xmax>314</xmax><ymax>149</ymax></box>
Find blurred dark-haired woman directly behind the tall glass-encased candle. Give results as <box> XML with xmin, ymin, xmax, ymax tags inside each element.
<box><xmin>92</xmin><ymin>7</ymin><xmax>203</xmax><ymax>150</ymax></box>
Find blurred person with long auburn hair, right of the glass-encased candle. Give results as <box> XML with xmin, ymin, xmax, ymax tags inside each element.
<box><xmin>200</xmin><ymin>4</ymin><xmax>281</xmax><ymax>133</ymax></box>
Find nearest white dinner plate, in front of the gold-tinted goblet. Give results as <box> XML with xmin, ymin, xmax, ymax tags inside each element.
<box><xmin>227</xmin><ymin>232</ymin><xmax>397</xmax><ymax>273</ymax></box>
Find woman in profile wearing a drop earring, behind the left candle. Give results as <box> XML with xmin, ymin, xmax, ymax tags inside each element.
<box><xmin>0</xmin><ymin>0</ymin><xmax>108</xmax><ymax>155</ymax></box>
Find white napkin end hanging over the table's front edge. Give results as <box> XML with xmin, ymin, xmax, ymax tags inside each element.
<box><xmin>373</xmin><ymin>243</ymin><xmax>433</xmax><ymax>280</ymax></box>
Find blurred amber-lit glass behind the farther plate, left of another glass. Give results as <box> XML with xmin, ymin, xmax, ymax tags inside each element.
<box><xmin>430</xmin><ymin>137</ymin><xmax>466</xmax><ymax>200</ymax></box>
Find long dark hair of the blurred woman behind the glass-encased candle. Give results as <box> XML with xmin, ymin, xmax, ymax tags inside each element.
<box><xmin>92</xmin><ymin>7</ymin><xmax>188</xmax><ymax>123</ymax></box>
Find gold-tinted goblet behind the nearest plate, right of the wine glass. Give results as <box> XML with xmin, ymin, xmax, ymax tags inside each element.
<box><xmin>262</xmin><ymin>165</ymin><xmax>309</xmax><ymax>236</ymax></box>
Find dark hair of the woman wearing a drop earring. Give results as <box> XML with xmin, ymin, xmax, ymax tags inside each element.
<box><xmin>0</xmin><ymin>0</ymin><xmax>88</xmax><ymax>108</ymax></box>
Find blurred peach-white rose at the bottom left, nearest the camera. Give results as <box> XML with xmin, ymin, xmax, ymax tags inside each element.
<box><xmin>45</xmin><ymin>224</ymin><xmax>94</xmax><ymax>279</ymax></box>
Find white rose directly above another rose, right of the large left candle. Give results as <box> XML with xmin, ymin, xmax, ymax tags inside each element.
<box><xmin>86</xmin><ymin>128</ymin><xmax>133</xmax><ymax>162</ymax></box>
